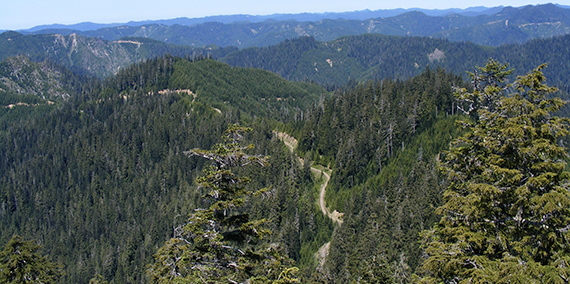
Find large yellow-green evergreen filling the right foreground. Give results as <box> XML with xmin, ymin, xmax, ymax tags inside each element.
<box><xmin>421</xmin><ymin>60</ymin><xmax>570</xmax><ymax>283</ymax></box>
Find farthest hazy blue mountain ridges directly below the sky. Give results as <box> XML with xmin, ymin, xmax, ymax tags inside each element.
<box><xmin>23</xmin><ymin>4</ymin><xmax>570</xmax><ymax>48</ymax></box>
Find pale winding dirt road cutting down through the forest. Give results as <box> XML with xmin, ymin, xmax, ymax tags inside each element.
<box><xmin>275</xmin><ymin>132</ymin><xmax>343</xmax><ymax>267</ymax></box>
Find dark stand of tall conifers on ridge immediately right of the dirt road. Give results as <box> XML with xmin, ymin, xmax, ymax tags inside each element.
<box><xmin>299</xmin><ymin>66</ymin><xmax>463</xmax><ymax>186</ymax></box>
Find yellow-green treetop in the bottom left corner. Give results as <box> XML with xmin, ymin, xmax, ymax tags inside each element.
<box><xmin>0</xmin><ymin>235</ymin><xmax>62</xmax><ymax>284</ymax></box>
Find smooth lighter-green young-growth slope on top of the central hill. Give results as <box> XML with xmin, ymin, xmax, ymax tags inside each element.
<box><xmin>168</xmin><ymin>60</ymin><xmax>324</xmax><ymax>119</ymax></box>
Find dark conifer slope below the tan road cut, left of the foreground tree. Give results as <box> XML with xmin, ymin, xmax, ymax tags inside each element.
<box><xmin>2</xmin><ymin>88</ymin><xmax>217</xmax><ymax>282</ymax></box>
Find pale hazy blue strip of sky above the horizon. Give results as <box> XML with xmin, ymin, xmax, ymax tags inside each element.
<box><xmin>0</xmin><ymin>0</ymin><xmax>570</xmax><ymax>30</ymax></box>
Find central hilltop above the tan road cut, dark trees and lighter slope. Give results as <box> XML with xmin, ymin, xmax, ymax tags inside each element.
<box><xmin>99</xmin><ymin>56</ymin><xmax>324</xmax><ymax>119</ymax></box>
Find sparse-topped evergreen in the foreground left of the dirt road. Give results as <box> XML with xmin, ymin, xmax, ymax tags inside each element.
<box><xmin>149</xmin><ymin>125</ymin><xmax>297</xmax><ymax>283</ymax></box>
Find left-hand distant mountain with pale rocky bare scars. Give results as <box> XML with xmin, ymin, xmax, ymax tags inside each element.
<box><xmin>0</xmin><ymin>32</ymin><xmax>235</xmax><ymax>77</ymax></box>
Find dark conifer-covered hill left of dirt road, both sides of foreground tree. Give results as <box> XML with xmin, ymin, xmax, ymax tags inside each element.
<box><xmin>0</xmin><ymin>57</ymin><xmax>332</xmax><ymax>283</ymax></box>
